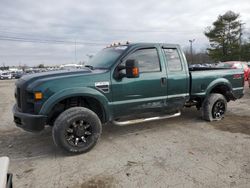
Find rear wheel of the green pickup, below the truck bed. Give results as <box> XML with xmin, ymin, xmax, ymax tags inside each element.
<box><xmin>202</xmin><ymin>93</ymin><xmax>227</xmax><ymax>121</ymax></box>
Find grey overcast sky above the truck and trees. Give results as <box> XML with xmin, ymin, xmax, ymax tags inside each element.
<box><xmin>0</xmin><ymin>0</ymin><xmax>250</xmax><ymax>66</ymax></box>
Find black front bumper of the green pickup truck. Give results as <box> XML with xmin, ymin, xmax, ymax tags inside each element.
<box><xmin>12</xmin><ymin>105</ymin><xmax>47</xmax><ymax>132</ymax></box>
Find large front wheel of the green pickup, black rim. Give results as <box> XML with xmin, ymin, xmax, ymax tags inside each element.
<box><xmin>52</xmin><ymin>107</ymin><xmax>102</xmax><ymax>154</ymax></box>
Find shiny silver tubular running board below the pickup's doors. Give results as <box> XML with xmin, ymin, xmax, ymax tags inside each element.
<box><xmin>112</xmin><ymin>112</ymin><xmax>181</xmax><ymax>126</ymax></box>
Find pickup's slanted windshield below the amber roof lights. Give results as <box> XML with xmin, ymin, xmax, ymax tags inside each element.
<box><xmin>87</xmin><ymin>46</ymin><xmax>127</xmax><ymax>68</ymax></box>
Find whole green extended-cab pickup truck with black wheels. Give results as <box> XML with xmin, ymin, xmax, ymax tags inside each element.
<box><xmin>13</xmin><ymin>43</ymin><xmax>244</xmax><ymax>153</ymax></box>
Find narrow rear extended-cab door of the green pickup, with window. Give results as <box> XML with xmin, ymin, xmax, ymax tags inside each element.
<box><xmin>162</xmin><ymin>45</ymin><xmax>190</xmax><ymax>112</ymax></box>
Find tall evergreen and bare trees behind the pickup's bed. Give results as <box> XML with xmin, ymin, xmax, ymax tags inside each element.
<box><xmin>184</xmin><ymin>11</ymin><xmax>250</xmax><ymax>64</ymax></box>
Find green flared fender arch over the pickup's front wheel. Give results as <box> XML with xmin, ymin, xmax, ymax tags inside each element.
<box><xmin>39</xmin><ymin>87</ymin><xmax>110</xmax><ymax>118</ymax></box>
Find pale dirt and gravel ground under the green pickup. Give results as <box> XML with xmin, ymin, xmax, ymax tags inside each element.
<box><xmin>0</xmin><ymin>80</ymin><xmax>250</xmax><ymax>188</ymax></box>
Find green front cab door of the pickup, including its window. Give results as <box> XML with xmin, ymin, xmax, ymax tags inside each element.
<box><xmin>111</xmin><ymin>47</ymin><xmax>167</xmax><ymax>117</ymax></box>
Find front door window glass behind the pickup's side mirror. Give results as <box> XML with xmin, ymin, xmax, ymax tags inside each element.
<box><xmin>121</xmin><ymin>48</ymin><xmax>161</xmax><ymax>73</ymax></box>
